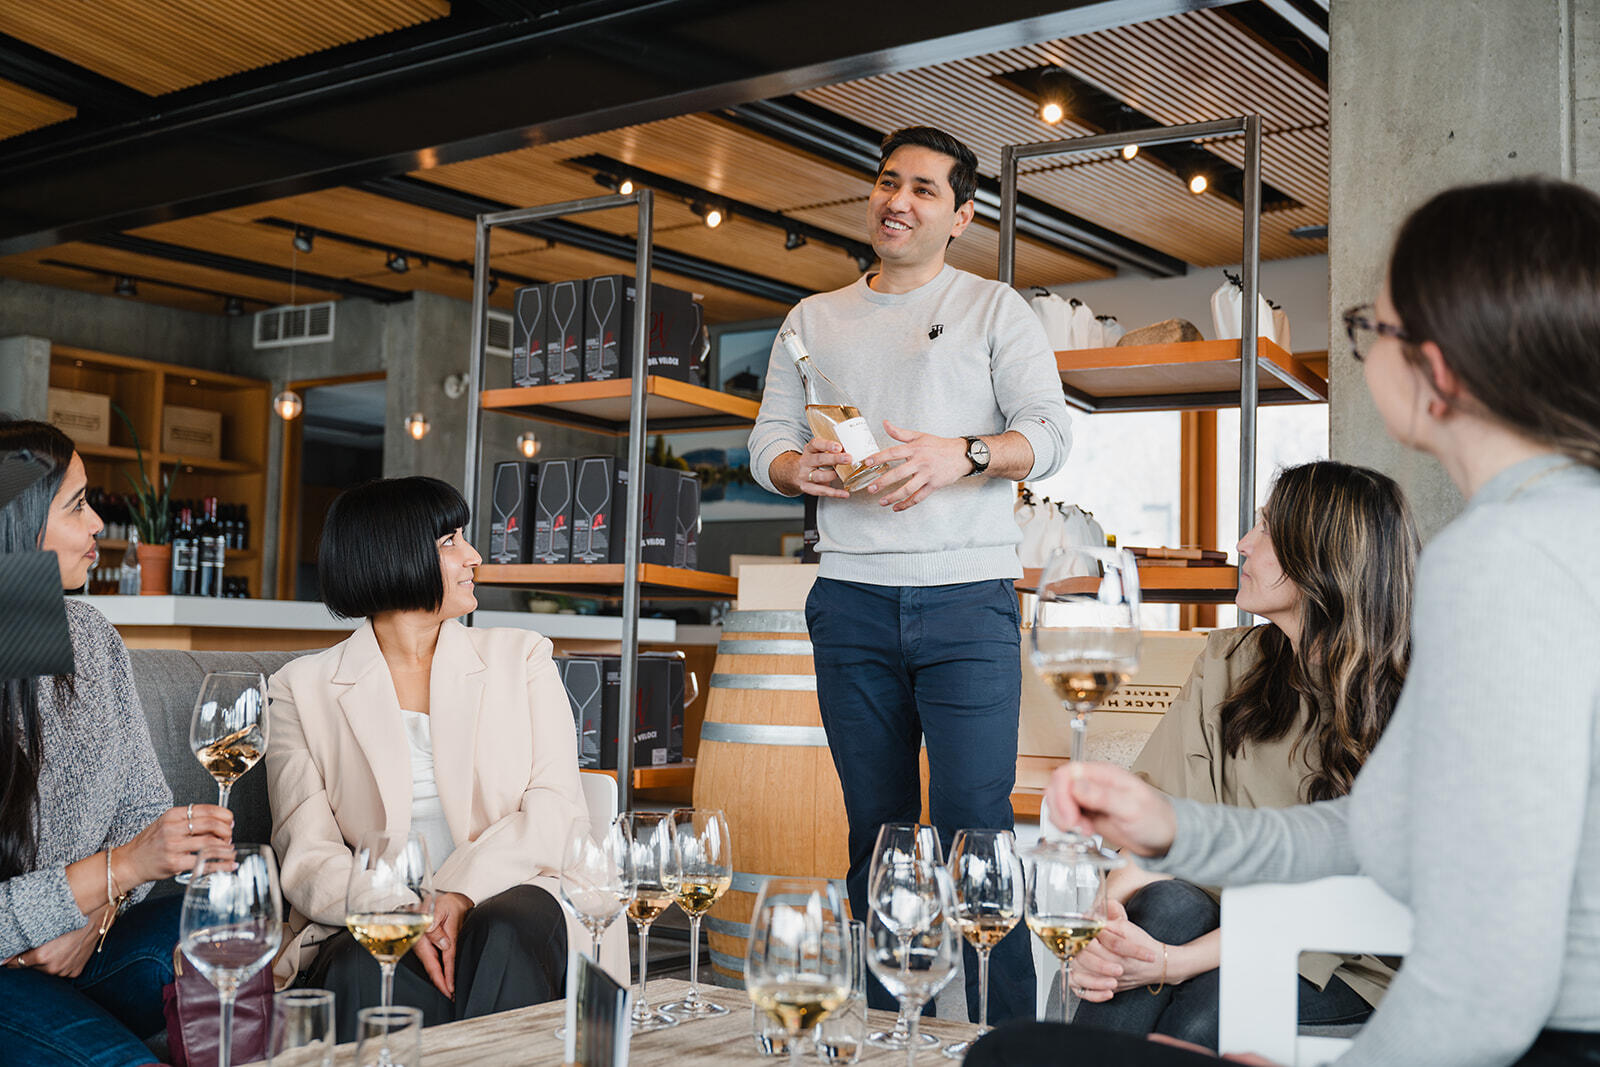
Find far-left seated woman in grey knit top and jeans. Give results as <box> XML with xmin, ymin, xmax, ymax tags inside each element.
<box><xmin>0</xmin><ymin>418</ymin><xmax>234</xmax><ymax>1067</ymax></box>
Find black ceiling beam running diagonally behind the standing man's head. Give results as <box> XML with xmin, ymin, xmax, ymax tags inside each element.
<box><xmin>722</xmin><ymin>96</ymin><xmax>1189</xmax><ymax>278</ymax></box>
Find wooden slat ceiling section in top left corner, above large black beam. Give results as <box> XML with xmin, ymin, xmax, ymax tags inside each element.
<box><xmin>0</xmin><ymin>0</ymin><xmax>450</xmax><ymax>96</ymax></box>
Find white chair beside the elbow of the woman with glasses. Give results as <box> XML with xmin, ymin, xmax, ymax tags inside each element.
<box><xmin>1219</xmin><ymin>877</ymin><xmax>1411</xmax><ymax>1067</ymax></box>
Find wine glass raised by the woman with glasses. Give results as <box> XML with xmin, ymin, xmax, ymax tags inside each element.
<box><xmin>1029</xmin><ymin>547</ymin><xmax>1139</xmax><ymax>849</ymax></box>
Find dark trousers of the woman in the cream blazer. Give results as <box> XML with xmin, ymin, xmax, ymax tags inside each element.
<box><xmin>302</xmin><ymin>886</ymin><xmax>566</xmax><ymax>1041</ymax></box>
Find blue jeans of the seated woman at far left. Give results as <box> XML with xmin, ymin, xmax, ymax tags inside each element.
<box><xmin>0</xmin><ymin>896</ymin><xmax>184</xmax><ymax>1067</ymax></box>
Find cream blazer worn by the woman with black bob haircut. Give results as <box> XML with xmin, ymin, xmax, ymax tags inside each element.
<box><xmin>266</xmin><ymin>619</ymin><xmax>629</xmax><ymax>985</ymax></box>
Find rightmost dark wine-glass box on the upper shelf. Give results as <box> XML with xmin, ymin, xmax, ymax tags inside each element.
<box><xmin>584</xmin><ymin>274</ymin><xmax>702</xmax><ymax>382</ymax></box>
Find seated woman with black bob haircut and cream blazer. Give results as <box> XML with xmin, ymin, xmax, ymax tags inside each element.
<box><xmin>266</xmin><ymin>477</ymin><xmax>627</xmax><ymax>1040</ymax></box>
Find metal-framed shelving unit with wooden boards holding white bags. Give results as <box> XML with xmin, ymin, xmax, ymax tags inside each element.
<box><xmin>998</xmin><ymin>115</ymin><xmax>1292</xmax><ymax>622</ymax></box>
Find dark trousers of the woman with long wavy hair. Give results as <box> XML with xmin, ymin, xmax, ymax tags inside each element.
<box><xmin>1072</xmin><ymin>880</ymin><xmax>1373</xmax><ymax>1049</ymax></box>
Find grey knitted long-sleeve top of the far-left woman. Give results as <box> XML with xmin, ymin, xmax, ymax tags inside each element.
<box><xmin>0</xmin><ymin>598</ymin><xmax>173</xmax><ymax>958</ymax></box>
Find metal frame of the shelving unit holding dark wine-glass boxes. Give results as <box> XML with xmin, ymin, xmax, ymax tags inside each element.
<box><xmin>461</xmin><ymin>189</ymin><xmax>654</xmax><ymax>811</ymax></box>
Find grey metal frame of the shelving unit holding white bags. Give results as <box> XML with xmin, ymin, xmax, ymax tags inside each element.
<box><xmin>1000</xmin><ymin>115</ymin><xmax>1261</xmax><ymax>624</ymax></box>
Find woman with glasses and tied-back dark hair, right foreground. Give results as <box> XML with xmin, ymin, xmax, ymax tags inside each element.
<box><xmin>966</xmin><ymin>178</ymin><xmax>1600</xmax><ymax>1067</ymax></box>
